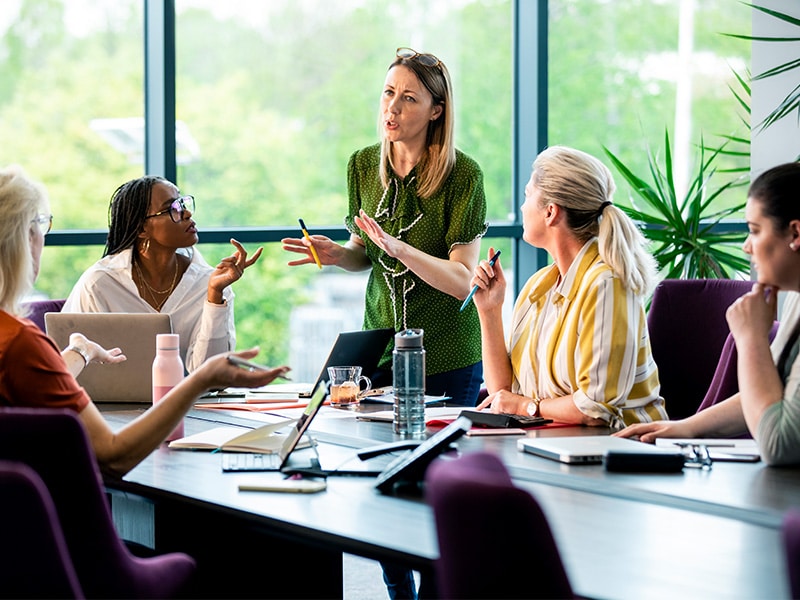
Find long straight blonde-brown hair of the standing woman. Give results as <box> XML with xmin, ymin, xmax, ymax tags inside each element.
<box><xmin>378</xmin><ymin>53</ymin><xmax>456</xmax><ymax>198</ymax></box>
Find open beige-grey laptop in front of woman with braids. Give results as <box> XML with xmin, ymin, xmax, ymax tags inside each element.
<box><xmin>44</xmin><ymin>312</ymin><xmax>172</xmax><ymax>403</ymax></box>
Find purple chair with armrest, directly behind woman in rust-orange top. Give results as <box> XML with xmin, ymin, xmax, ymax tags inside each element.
<box><xmin>0</xmin><ymin>408</ymin><xmax>196</xmax><ymax>598</ymax></box>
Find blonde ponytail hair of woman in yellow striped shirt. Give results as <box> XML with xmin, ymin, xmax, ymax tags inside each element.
<box><xmin>533</xmin><ymin>146</ymin><xmax>656</xmax><ymax>296</ymax></box>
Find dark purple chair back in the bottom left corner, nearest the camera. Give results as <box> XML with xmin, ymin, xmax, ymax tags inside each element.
<box><xmin>0</xmin><ymin>460</ymin><xmax>85</xmax><ymax>598</ymax></box>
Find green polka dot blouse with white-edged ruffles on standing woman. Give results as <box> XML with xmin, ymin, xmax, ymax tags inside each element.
<box><xmin>345</xmin><ymin>144</ymin><xmax>487</xmax><ymax>375</ymax></box>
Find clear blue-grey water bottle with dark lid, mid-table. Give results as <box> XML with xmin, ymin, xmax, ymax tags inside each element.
<box><xmin>392</xmin><ymin>329</ymin><xmax>425</xmax><ymax>437</ymax></box>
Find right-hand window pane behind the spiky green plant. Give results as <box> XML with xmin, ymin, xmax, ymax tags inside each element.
<box><xmin>547</xmin><ymin>0</ymin><xmax>751</xmax><ymax>205</ymax></box>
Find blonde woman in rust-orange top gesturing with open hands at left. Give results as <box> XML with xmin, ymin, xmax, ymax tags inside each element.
<box><xmin>0</xmin><ymin>166</ymin><xmax>289</xmax><ymax>476</ymax></box>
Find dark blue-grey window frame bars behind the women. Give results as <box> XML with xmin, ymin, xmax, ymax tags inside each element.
<box><xmin>45</xmin><ymin>0</ymin><xmax>548</xmax><ymax>296</ymax></box>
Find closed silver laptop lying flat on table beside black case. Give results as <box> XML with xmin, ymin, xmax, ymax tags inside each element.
<box><xmin>517</xmin><ymin>435</ymin><xmax>674</xmax><ymax>464</ymax></box>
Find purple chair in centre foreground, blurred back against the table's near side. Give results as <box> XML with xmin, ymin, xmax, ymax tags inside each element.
<box><xmin>425</xmin><ymin>452</ymin><xmax>575</xmax><ymax>599</ymax></box>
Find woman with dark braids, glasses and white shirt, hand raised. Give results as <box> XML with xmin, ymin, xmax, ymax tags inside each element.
<box><xmin>63</xmin><ymin>176</ymin><xmax>261</xmax><ymax>372</ymax></box>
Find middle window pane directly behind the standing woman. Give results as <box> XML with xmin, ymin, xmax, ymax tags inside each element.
<box><xmin>175</xmin><ymin>0</ymin><xmax>512</xmax><ymax>370</ymax></box>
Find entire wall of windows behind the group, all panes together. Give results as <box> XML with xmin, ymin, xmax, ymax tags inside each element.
<box><xmin>0</xmin><ymin>0</ymin><xmax>750</xmax><ymax>370</ymax></box>
